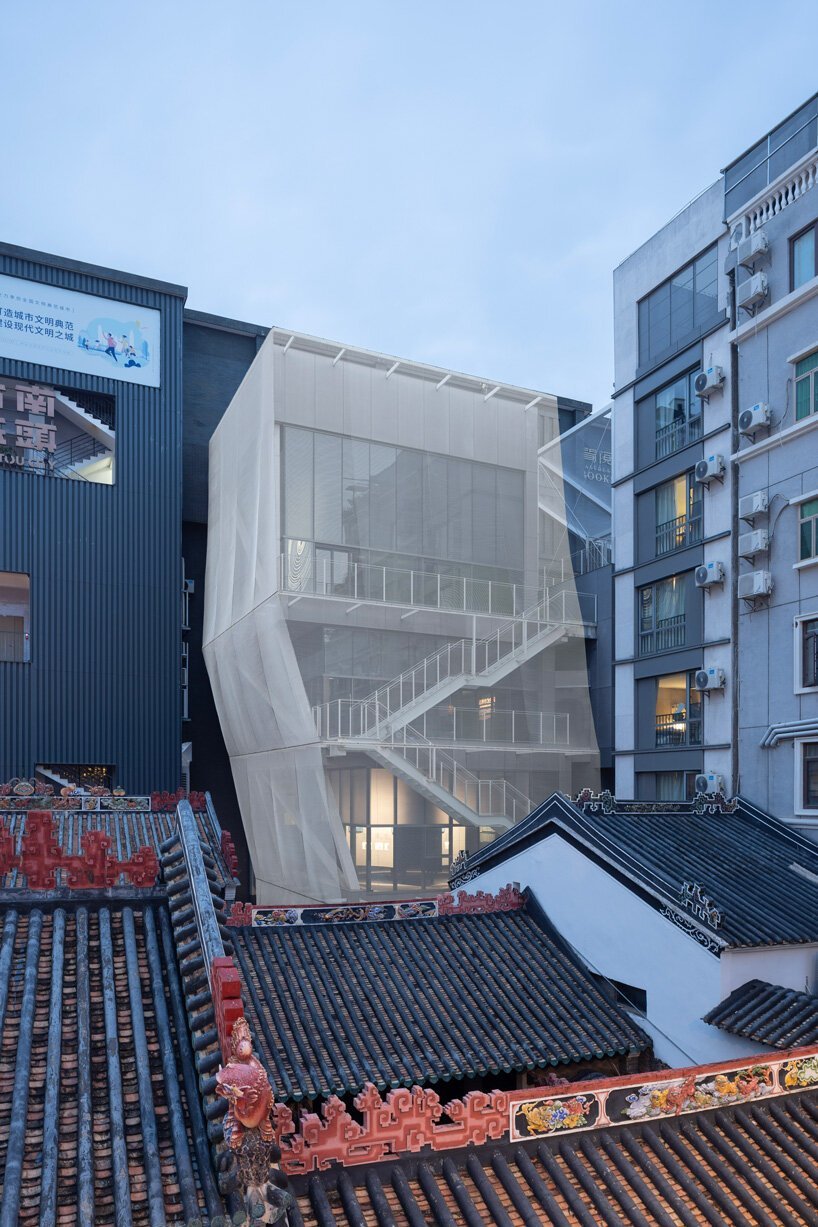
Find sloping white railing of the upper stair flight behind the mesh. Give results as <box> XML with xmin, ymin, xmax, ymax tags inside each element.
<box><xmin>316</xmin><ymin>589</ymin><xmax>596</xmax><ymax>737</ymax></box>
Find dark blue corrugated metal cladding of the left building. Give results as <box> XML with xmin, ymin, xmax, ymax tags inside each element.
<box><xmin>0</xmin><ymin>247</ymin><xmax>184</xmax><ymax>793</ymax></box>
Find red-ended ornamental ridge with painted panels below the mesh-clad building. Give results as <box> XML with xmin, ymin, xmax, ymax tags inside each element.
<box><xmin>227</xmin><ymin>888</ymin><xmax>525</xmax><ymax>929</ymax></box>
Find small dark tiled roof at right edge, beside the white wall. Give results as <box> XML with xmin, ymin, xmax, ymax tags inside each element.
<box><xmin>704</xmin><ymin>980</ymin><xmax>818</xmax><ymax>1048</ymax></box>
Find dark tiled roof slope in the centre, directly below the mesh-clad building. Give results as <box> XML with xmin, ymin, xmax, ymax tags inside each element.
<box><xmin>231</xmin><ymin>901</ymin><xmax>650</xmax><ymax>1101</ymax></box>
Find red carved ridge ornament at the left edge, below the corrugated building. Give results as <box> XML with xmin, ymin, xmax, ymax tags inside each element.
<box><xmin>0</xmin><ymin>810</ymin><xmax>159</xmax><ymax>891</ymax></box>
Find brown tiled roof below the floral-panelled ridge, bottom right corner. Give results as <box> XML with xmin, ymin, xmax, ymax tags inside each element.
<box><xmin>289</xmin><ymin>1092</ymin><xmax>818</xmax><ymax>1227</ymax></box>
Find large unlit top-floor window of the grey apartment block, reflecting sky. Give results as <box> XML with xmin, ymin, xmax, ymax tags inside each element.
<box><xmin>639</xmin><ymin>244</ymin><xmax>719</xmax><ymax>367</ymax></box>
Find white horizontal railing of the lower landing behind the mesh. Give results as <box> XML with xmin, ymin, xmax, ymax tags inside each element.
<box><xmin>313</xmin><ymin>698</ymin><xmax>570</xmax><ymax>747</ymax></box>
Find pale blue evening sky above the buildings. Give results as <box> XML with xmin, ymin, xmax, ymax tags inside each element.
<box><xmin>0</xmin><ymin>0</ymin><xmax>818</xmax><ymax>407</ymax></box>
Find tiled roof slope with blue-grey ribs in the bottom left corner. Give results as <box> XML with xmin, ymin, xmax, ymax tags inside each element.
<box><xmin>0</xmin><ymin>893</ymin><xmax>221</xmax><ymax>1227</ymax></box>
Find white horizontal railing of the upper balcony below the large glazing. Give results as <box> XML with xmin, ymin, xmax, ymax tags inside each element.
<box><xmin>280</xmin><ymin>545</ymin><xmax>541</xmax><ymax>617</ymax></box>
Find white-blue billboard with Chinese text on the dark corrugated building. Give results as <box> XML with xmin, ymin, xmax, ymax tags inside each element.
<box><xmin>0</xmin><ymin>274</ymin><xmax>162</xmax><ymax>388</ymax></box>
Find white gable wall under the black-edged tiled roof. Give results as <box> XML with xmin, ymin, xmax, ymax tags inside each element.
<box><xmin>465</xmin><ymin>834</ymin><xmax>770</xmax><ymax>1066</ymax></box>
